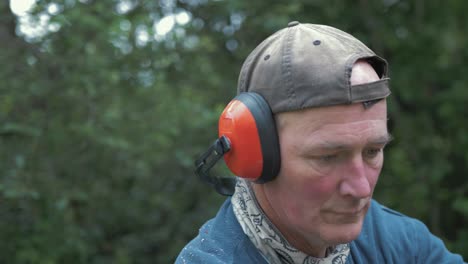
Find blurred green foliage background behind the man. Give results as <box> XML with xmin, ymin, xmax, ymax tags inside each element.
<box><xmin>0</xmin><ymin>0</ymin><xmax>468</xmax><ymax>264</ymax></box>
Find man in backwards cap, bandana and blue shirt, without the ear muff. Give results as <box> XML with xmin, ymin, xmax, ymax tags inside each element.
<box><xmin>177</xmin><ymin>22</ymin><xmax>463</xmax><ymax>263</ymax></box>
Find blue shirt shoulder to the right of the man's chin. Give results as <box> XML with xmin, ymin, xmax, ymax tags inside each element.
<box><xmin>350</xmin><ymin>201</ymin><xmax>463</xmax><ymax>263</ymax></box>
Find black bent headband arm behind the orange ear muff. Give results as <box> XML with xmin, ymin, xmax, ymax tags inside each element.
<box><xmin>195</xmin><ymin>136</ymin><xmax>235</xmax><ymax>196</ymax></box>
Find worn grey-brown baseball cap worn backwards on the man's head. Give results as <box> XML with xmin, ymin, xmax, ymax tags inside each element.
<box><xmin>237</xmin><ymin>21</ymin><xmax>390</xmax><ymax>113</ymax></box>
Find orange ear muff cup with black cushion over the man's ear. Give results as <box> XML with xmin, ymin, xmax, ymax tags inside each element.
<box><xmin>219</xmin><ymin>92</ymin><xmax>281</xmax><ymax>183</ymax></box>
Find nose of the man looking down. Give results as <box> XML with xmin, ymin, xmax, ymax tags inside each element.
<box><xmin>339</xmin><ymin>155</ymin><xmax>372</xmax><ymax>198</ymax></box>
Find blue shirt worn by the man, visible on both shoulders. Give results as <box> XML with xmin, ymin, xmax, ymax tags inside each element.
<box><xmin>176</xmin><ymin>198</ymin><xmax>463</xmax><ymax>264</ymax></box>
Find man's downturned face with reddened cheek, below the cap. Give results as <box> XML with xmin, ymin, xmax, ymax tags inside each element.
<box><xmin>254</xmin><ymin>100</ymin><xmax>390</xmax><ymax>250</ymax></box>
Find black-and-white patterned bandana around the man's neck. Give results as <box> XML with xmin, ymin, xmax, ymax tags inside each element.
<box><xmin>231</xmin><ymin>179</ymin><xmax>349</xmax><ymax>264</ymax></box>
